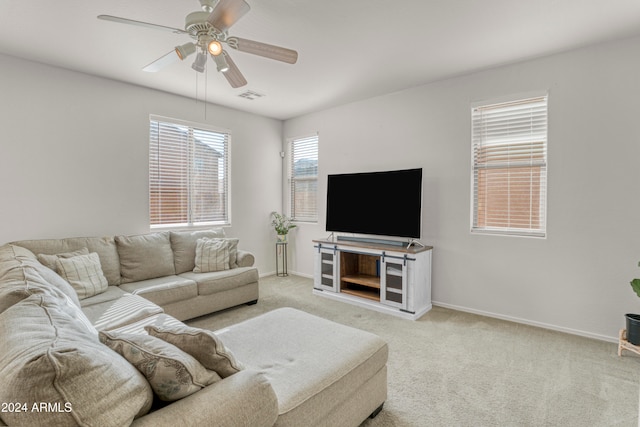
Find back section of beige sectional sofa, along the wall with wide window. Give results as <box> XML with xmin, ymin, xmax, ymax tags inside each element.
<box><xmin>12</xmin><ymin>228</ymin><xmax>258</xmax><ymax>320</ymax></box>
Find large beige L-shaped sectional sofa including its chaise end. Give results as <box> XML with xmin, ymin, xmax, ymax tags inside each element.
<box><xmin>0</xmin><ymin>231</ymin><xmax>388</xmax><ymax>427</ymax></box>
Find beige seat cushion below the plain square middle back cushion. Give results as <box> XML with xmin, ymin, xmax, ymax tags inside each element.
<box><xmin>120</xmin><ymin>276</ymin><xmax>198</xmax><ymax>306</ymax></box>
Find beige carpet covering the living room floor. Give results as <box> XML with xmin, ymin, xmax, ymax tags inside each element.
<box><xmin>188</xmin><ymin>276</ymin><xmax>640</xmax><ymax>427</ymax></box>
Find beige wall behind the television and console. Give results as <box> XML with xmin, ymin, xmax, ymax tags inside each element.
<box><xmin>284</xmin><ymin>38</ymin><xmax>640</xmax><ymax>341</ymax></box>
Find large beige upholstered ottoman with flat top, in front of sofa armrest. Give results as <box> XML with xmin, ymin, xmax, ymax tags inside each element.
<box><xmin>216</xmin><ymin>308</ymin><xmax>388</xmax><ymax>427</ymax></box>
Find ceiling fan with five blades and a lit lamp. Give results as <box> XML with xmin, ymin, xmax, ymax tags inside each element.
<box><xmin>98</xmin><ymin>0</ymin><xmax>298</xmax><ymax>88</ymax></box>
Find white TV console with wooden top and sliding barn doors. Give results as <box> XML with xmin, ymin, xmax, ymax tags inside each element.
<box><xmin>313</xmin><ymin>240</ymin><xmax>433</xmax><ymax>320</ymax></box>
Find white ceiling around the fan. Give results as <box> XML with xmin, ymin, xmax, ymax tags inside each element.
<box><xmin>0</xmin><ymin>0</ymin><xmax>640</xmax><ymax>119</ymax></box>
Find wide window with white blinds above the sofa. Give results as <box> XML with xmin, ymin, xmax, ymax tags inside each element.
<box><xmin>149</xmin><ymin>116</ymin><xmax>231</xmax><ymax>227</ymax></box>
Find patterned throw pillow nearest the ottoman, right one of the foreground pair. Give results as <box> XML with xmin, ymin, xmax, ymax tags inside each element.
<box><xmin>145</xmin><ymin>325</ymin><xmax>244</xmax><ymax>378</ymax></box>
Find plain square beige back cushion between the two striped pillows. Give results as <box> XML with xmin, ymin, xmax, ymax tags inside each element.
<box><xmin>115</xmin><ymin>232</ymin><xmax>175</xmax><ymax>283</ymax></box>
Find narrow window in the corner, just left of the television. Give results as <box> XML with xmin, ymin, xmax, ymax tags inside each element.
<box><xmin>289</xmin><ymin>135</ymin><xmax>318</xmax><ymax>222</ymax></box>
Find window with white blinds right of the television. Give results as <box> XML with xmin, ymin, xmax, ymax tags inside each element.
<box><xmin>471</xmin><ymin>95</ymin><xmax>547</xmax><ymax>237</ymax></box>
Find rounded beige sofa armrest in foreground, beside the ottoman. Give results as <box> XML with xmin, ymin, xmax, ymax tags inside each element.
<box><xmin>131</xmin><ymin>370</ymin><xmax>278</xmax><ymax>427</ymax></box>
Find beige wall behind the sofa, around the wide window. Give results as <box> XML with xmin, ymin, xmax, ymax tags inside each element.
<box><xmin>0</xmin><ymin>55</ymin><xmax>282</xmax><ymax>274</ymax></box>
